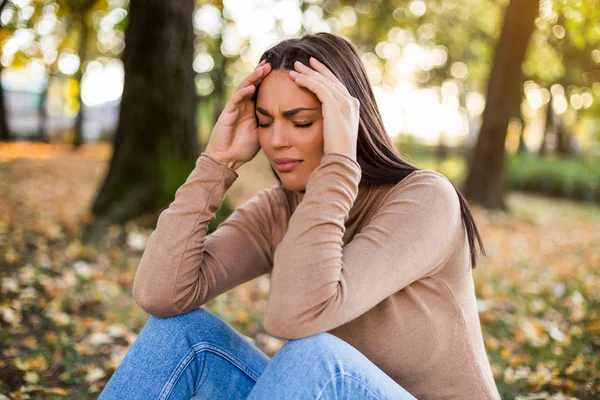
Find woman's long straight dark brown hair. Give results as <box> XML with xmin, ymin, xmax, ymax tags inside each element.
<box><xmin>252</xmin><ymin>32</ymin><xmax>486</xmax><ymax>268</ymax></box>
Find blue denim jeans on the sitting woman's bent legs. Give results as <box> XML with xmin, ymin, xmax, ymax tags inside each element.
<box><xmin>98</xmin><ymin>308</ymin><xmax>415</xmax><ymax>400</ymax></box>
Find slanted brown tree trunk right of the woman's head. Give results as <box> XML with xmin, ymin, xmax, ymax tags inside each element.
<box><xmin>463</xmin><ymin>0</ymin><xmax>539</xmax><ymax>209</ymax></box>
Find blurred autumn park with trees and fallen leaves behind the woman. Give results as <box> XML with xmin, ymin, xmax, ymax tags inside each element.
<box><xmin>0</xmin><ymin>0</ymin><xmax>600</xmax><ymax>400</ymax></box>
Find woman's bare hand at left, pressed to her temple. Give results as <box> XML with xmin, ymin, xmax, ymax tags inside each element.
<box><xmin>204</xmin><ymin>60</ymin><xmax>271</xmax><ymax>169</ymax></box>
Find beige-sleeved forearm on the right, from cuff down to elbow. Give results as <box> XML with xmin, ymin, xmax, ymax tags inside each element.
<box><xmin>265</xmin><ymin>155</ymin><xmax>361</xmax><ymax>335</ymax></box>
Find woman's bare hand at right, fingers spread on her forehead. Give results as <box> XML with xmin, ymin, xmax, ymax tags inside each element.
<box><xmin>290</xmin><ymin>57</ymin><xmax>360</xmax><ymax>160</ymax></box>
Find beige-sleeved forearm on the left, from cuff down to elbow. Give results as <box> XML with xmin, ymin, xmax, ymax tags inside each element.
<box><xmin>133</xmin><ymin>153</ymin><xmax>238</xmax><ymax>316</ymax></box>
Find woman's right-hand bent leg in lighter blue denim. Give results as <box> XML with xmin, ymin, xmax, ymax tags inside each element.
<box><xmin>248</xmin><ymin>332</ymin><xmax>416</xmax><ymax>400</ymax></box>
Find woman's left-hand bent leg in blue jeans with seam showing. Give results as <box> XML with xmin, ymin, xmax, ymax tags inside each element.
<box><xmin>98</xmin><ymin>308</ymin><xmax>270</xmax><ymax>400</ymax></box>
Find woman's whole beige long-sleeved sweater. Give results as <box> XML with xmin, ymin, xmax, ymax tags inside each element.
<box><xmin>133</xmin><ymin>153</ymin><xmax>500</xmax><ymax>400</ymax></box>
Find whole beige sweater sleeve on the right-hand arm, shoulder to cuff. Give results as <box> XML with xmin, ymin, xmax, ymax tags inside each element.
<box><xmin>264</xmin><ymin>153</ymin><xmax>462</xmax><ymax>339</ymax></box>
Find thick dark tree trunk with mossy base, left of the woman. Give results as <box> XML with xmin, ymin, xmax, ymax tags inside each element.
<box><xmin>84</xmin><ymin>0</ymin><xmax>199</xmax><ymax>241</ymax></box>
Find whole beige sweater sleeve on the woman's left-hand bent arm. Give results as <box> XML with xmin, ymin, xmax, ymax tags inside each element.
<box><xmin>133</xmin><ymin>153</ymin><xmax>272</xmax><ymax>317</ymax></box>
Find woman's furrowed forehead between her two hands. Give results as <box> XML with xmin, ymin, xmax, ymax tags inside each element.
<box><xmin>256</xmin><ymin>69</ymin><xmax>321</xmax><ymax>112</ymax></box>
